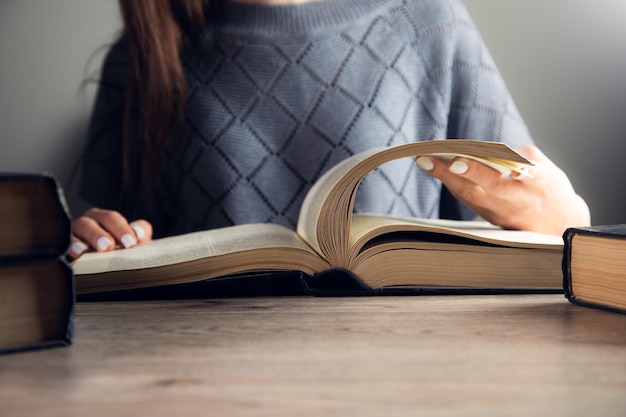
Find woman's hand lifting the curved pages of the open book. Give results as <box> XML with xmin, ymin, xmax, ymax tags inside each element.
<box><xmin>416</xmin><ymin>145</ymin><xmax>591</xmax><ymax>235</ymax></box>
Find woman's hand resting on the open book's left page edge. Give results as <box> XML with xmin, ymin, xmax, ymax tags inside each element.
<box><xmin>66</xmin><ymin>208</ymin><xmax>152</xmax><ymax>259</ymax></box>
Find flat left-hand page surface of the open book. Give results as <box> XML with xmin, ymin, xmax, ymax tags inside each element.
<box><xmin>72</xmin><ymin>224</ymin><xmax>322</xmax><ymax>275</ymax></box>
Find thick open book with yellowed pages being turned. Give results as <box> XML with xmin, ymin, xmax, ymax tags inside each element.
<box><xmin>73</xmin><ymin>140</ymin><xmax>563</xmax><ymax>294</ymax></box>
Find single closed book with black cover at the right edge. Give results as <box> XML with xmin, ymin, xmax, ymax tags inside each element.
<box><xmin>563</xmin><ymin>224</ymin><xmax>626</xmax><ymax>313</ymax></box>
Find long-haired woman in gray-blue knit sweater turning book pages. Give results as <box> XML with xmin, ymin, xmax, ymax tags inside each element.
<box><xmin>68</xmin><ymin>0</ymin><xmax>590</xmax><ymax>257</ymax></box>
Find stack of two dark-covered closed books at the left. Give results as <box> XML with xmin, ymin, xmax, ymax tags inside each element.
<box><xmin>0</xmin><ymin>173</ymin><xmax>74</xmax><ymax>353</ymax></box>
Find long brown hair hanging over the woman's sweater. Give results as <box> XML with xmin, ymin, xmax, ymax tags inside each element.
<box><xmin>119</xmin><ymin>0</ymin><xmax>213</xmax><ymax>186</ymax></box>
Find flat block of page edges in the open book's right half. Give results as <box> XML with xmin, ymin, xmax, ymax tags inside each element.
<box><xmin>352</xmin><ymin>242</ymin><xmax>563</xmax><ymax>291</ymax></box>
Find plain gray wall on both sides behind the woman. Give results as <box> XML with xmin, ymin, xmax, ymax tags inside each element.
<box><xmin>0</xmin><ymin>0</ymin><xmax>626</xmax><ymax>224</ymax></box>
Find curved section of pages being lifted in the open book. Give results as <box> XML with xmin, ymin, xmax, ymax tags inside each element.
<box><xmin>298</xmin><ymin>139</ymin><xmax>532</xmax><ymax>268</ymax></box>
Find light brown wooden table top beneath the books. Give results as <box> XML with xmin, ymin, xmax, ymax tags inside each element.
<box><xmin>0</xmin><ymin>295</ymin><xmax>626</xmax><ymax>417</ymax></box>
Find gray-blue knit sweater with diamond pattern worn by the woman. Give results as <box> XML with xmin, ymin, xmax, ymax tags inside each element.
<box><xmin>81</xmin><ymin>0</ymin><xmax>532</xmax><ymax>236</ymax></box>
